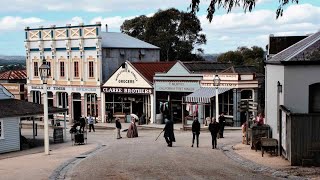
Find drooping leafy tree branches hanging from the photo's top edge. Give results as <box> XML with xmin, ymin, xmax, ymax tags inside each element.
<box><xmin>190</xmin><ymin>0</ymin><xmax>299</xmax><ymax>22</ymax></box>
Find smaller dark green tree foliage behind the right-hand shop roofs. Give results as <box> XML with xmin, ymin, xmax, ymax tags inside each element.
<box><xmin>218</xmin><ymin>46</ymin><xmax>265</xmax><ymax>73</ymax></box>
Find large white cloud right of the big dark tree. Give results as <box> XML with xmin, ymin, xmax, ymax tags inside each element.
<box><xmin>199</xmin><ymin>4</ymin><xmax>320</xmax><ymax>53</ymax></box>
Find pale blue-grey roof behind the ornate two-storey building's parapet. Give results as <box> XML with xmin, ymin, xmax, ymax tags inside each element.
<box><xmin>101</xmin><ymin>32</ymin><xmax>160</xmax><ymax>49</ymax></box>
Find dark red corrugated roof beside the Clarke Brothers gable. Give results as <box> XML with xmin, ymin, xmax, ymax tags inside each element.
<box><xmin>131</xmin><ymin>61</ymin><xmax>176</xmax><ymax>83</ymax></box>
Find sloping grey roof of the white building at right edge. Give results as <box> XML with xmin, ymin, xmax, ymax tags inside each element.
<box><xmin>266</xmin><ymin>31</ymin><xmax>320</xmax><ymax>63</ymax></box>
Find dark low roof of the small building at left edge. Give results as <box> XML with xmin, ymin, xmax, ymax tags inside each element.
<box><xmin>0</xmin><ymin>99</ymin><xmax>67</xmax><ymax>118</ymax></box>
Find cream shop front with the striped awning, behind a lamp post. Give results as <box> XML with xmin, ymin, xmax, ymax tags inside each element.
<box><xmin>185</xmin><ymin>73</ymin><xmax>258</xmax><ymax>127</ymax></box>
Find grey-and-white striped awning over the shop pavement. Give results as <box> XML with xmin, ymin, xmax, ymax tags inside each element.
<box><xmin>185</xmin><ymin>87</ymin><xmax>230</xmax><ymax>103</ymax></box>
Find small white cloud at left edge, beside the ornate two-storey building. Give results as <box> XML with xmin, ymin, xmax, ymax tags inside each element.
<box><xmin>0</xmin><ymin>16</ymin><xmax>44</xmax><ymax>31</ymax></box>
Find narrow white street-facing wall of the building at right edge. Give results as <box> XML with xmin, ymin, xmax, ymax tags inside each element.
<box><xmin>265</xmin><ymin>64</ymin><xmax>285</xmax><ymax>139</ymax></box>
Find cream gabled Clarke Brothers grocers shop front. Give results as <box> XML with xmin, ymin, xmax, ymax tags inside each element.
<box><xmin>101</xmin><ymin>62</ymin><xmax>153</xmax><ymax>124</ymax></box>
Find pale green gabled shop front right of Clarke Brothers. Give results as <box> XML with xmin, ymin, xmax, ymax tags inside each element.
<box><xmin>153</xmin><ymin>61</ymin><xmax>202</xmax><ymax>124</ymax></box>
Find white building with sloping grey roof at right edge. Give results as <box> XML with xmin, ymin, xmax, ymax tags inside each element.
<box><xmin>265</xmin><ymin>32</ymin><xmax>320</xmax><ymax>165</ymax></box>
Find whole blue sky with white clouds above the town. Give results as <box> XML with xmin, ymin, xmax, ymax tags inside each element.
<box><xmin>0</xmin><ymin>0</ymin><xmax>320</xmax><ymax>56</ymax></box>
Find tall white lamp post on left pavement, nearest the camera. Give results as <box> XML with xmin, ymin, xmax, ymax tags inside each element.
<box><xmin>39</xmin><ymin>59</ymin><xmax>50</xmax><ymax>155</ymax></box>
